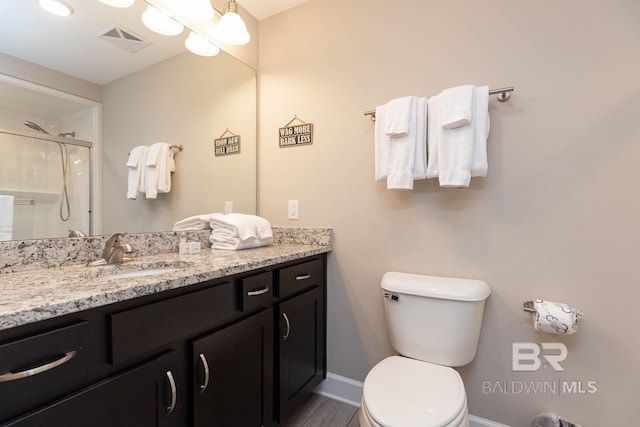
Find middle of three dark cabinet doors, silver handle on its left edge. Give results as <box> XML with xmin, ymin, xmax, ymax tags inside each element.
<box><xmin>193</xmin><ymin>309</ymin><xmax>273</xmax><ymax>427</ymax></box>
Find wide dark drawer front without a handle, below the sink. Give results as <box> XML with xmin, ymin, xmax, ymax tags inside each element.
<box><xmin>110</xmin><ymin>282</ymin><xmax>236</xmax><ymax>365</ymax></box>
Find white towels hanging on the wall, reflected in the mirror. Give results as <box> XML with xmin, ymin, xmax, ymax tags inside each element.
<box><xmin>127</xmin><ymin>142</ymin><xmax>176</xmax><ymax>200</ymax></box>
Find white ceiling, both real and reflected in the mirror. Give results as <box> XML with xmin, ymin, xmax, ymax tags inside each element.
<box><xmin>0</xmin><ymin>0</ymin><xmax>308</xmax><ymax>85</ymax></box>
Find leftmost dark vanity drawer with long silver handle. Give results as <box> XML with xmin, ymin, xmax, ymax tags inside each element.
<box><xmin>0</xmin><ymin>322</ymin><xmax>90</xmax><ymax>421</ymax></box>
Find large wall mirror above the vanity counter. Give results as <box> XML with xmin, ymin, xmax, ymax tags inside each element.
<box><xmin>0</xmin><ymin>0</ymin><xmax>257</xmax><ymax>240</ymax></box>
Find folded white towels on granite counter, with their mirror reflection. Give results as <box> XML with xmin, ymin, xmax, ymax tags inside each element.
<box><xmin>173</xmin><ymin>213</ymin><xmax>273</xmax><ymax>250</ymax></box>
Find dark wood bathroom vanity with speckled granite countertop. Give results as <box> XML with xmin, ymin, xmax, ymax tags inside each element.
<box><xmin>0</xmin><ymin>232</ymin><xmax>330</xmax><ymax>426</ymax></box>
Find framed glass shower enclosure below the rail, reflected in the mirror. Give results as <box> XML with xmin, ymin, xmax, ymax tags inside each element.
<box><xmin>0</xmin><ymin>128</ymin><xmax>93</xmax><ymax>240</ymax></box>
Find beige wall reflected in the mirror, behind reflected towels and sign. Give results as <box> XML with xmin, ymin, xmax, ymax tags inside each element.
<box><xmin>102</xmin><ymin>52</ymin><xmax>256</xmax><ymax>234</ymax></box>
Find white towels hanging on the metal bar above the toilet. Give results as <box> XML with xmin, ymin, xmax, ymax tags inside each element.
<box><xmin>375</xmin><ymin>85</ymin><xmax>489</xmax><ymax>190</ymax></box>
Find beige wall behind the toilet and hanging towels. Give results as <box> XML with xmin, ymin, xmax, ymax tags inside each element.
<box><xmin>259</xmin><ymin>0</ymin><xmax>640</xmax><ymax>426</ymax></box>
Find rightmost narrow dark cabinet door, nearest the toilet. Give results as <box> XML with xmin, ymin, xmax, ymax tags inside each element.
<box><xmin>278</xmin><ymin>287</ymin><xmax>325</xmax><ymax>421</ymax></box>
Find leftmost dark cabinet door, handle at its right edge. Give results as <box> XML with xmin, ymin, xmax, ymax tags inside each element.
<box><xmin>7</xmin><ymin>352</ymin><xmax>184</xmax><ymax>427</ymax></box>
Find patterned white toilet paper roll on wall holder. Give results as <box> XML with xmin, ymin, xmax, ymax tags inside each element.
<box><xmin>533</xmin><ymin>299</ymin><xmax>584</xmax><ymax>335</ymax></box>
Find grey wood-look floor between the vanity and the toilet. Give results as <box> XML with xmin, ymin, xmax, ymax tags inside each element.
<box><xmin>280</xmin><ymin>393</ymin><xmax>360</xmax><ymax>427</ymax></box>
